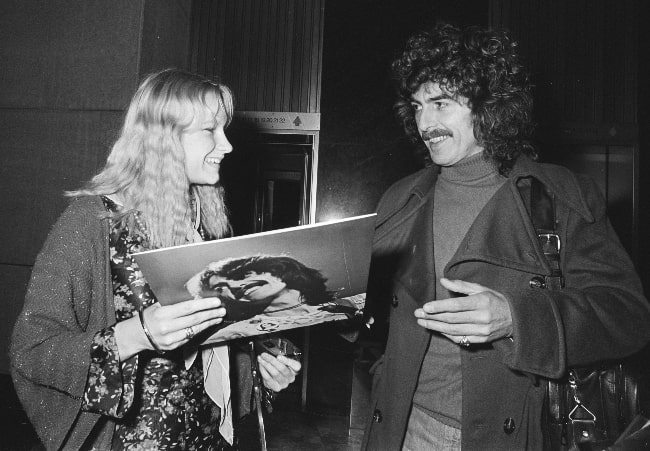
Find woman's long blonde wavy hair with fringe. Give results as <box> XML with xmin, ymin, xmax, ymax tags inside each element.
<box><xmin>66</xmin><ymin>69</ymin><xmax>234</xmax><ymax>248</ymax></box>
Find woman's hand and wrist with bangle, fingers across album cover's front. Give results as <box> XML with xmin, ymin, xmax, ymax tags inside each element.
<box><xmin>115</xmin><ymin>298</ymin><xmax>226</xmax><ymax>361</ymax></box>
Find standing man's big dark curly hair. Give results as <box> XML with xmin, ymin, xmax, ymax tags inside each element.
<box><xmin>392</xmin><ymin>24</ymin><xmax>537</xmax><ymax>175</ymax></box>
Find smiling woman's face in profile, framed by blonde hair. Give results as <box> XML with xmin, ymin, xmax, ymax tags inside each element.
<box><xmin>180</xmin><ymin>93</ymin><xmax>232</xmax><ymax>185</ymax></box>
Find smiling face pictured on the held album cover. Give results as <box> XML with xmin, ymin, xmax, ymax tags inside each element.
<box><xmin>208</xmin><ymin>272</ymin><xmax>287</xmax><ymax>302</ymax></box>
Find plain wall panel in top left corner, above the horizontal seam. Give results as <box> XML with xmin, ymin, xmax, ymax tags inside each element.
<box><xmin>0</xmin><ymin>0</ymin><xmax>143</xmax><ymax>109</ymax></box>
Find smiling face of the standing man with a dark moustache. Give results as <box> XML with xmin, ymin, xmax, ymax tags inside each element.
<box><xmin>411</xmin><ymin>82</ymin><xmax>483</xmax><ymax>166</ymax></box>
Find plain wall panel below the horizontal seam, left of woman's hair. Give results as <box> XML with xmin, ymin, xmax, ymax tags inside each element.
<box><xmin>0</xmin><ymin>109</ymin><xmax>122</xmax><ymax>265</ymax></box>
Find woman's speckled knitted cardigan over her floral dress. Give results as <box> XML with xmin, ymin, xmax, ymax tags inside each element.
<box><xmin>10</xmin><ymin>196</ymin><xmax>250</xmax><ymax>449</ymax></box>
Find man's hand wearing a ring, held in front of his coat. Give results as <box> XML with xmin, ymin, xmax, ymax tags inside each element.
<box><xmin>415</xmin><ymin>278</ymin><xmax>512</xmax><ymax>345</ymax></box>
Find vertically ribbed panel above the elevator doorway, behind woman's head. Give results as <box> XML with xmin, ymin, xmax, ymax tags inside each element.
<box><xmin>191</xmin><ymin>0</ymin><xmax>324</xmax><ymax>113</ymax></box>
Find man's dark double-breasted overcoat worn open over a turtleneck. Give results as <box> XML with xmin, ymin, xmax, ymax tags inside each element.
<box><xmin>362</xmin><ymin>157</ymin><xmax>650</xmax><ymax>451</ymax></box>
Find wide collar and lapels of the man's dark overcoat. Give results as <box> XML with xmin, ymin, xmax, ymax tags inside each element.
<box><xmin>376</xmin><ymin>156</ymin><xmax>594</xmax><ymax>274</ymax></box>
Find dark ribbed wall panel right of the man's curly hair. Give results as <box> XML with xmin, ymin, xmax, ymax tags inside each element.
<box><xmin>490</xmin><ymin>0</ymin><xmax>640</xmax><ymax>130</ymax></box>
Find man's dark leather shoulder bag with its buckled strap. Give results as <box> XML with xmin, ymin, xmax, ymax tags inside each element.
<box><xmin>519</xmin><ymin>178</ymin><xmax>650</xmax><ymax>451</ymax></box>
